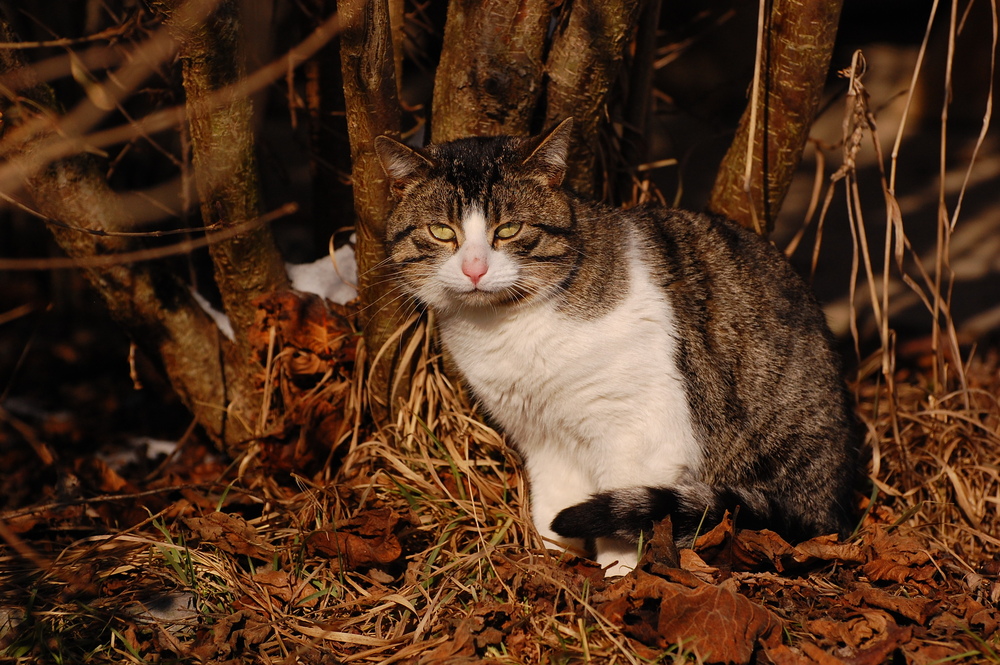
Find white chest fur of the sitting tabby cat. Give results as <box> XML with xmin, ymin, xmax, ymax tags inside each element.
<box><xmin>441</xmin><ymin>243</ymin><xmax>701</xmax><ymax>498</ymax></box>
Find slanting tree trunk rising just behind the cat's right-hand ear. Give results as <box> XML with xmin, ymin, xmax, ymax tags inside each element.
<box><xmin>545</xmin><ymin>0</ymin><xmax>639</xmax><ymax>196</ymax></box>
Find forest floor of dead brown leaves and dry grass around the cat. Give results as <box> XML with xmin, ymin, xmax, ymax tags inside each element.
<box><xmin>0</xmin><ymin>286</ymin><xmax>1000</xmax><ymax>665</ymax></box>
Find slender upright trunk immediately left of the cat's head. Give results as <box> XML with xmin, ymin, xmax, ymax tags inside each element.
<box><xmin>337</xmin><ymin>0</ymin><xmax>408</xmax><ymax>422</ymax></box>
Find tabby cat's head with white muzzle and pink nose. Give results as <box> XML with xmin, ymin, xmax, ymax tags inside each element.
<box><xmin>375</xmin><ymin>119</ymin><xmax>579</xmax><ymax>313</ymax></box>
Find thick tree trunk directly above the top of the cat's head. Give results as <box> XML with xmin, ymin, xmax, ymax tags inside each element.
<box><xmin>431</xmin><ymin>0</ymin><xmax>552</xmax><ymax>143</ymax></box>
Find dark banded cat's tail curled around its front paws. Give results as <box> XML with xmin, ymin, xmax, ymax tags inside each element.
<box><xmin>552</xmin><ymin>482</ymin><xmax>772</xmax><ymax>546</ymax></box>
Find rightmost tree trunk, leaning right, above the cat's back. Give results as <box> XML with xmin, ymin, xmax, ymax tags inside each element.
<box><xmin>708</xmin><ymin>0</ymin><xmax>843</xmax><ymax>235</ymax></box>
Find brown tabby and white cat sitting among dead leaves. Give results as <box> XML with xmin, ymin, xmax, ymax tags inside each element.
<box><xmin>375</xmin><ymin>118</ymin><xmax>859</xmax><ymax>575</ymax></box>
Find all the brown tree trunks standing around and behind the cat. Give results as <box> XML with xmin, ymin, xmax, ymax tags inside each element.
<box><xmin>0</xmin><ymin>0</ymin><xmax>841</xmax><ymax>453</ymax></box>
